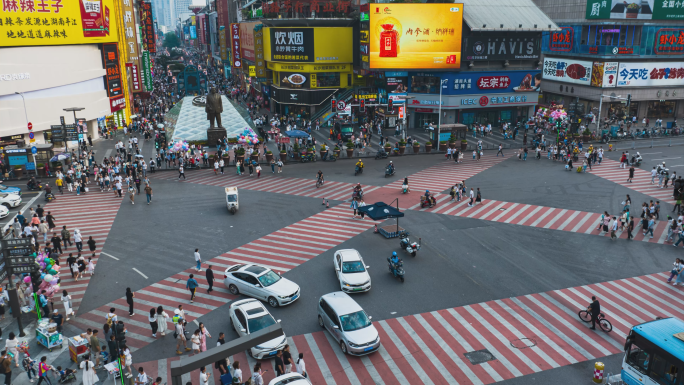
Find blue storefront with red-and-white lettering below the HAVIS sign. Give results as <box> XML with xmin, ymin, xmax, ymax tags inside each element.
<box><xmin>406</xmin><ymin>71</ymin><xmax>541</xmax><ymax>127</ymax></box>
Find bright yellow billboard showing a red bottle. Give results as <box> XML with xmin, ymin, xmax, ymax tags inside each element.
<box><xmin>369</xmin><ymin>3</ymin><xmax>463</xmax><ymax>69</ymax></box>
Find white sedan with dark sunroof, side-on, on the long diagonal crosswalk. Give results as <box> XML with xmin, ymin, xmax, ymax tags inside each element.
<box><xmin>223</xmin><ymin>264</ymin><xmax>299</xmax><ymax>307</ymax></box>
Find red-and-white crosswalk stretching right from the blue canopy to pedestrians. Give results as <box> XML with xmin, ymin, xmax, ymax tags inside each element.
<box><xmin>420</xmin><ymin>194</ymin><xmax>667</xmax><ymax>244</ymax></box>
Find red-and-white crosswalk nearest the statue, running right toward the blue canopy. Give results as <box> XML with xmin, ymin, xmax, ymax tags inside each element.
<box><xmin>148</xmin><ymin>168</ymin><xmax>380</xmax><ymax>200</ymax></box>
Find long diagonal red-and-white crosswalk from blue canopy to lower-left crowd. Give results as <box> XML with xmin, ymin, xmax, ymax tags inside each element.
<box><xmin>72</xmin><ymin>205</ymin><xmax>378</xmax><ymax>348</ymax></box>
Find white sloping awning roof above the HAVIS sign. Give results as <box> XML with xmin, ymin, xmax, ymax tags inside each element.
<box><xmin>459</xmin><ymin>0</ymin><xmax>560</xmax><ymax>32</ymax></box>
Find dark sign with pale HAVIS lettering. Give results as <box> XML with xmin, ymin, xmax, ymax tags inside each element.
<box><xmin>463</xmin><ymin>33</ymin><xmax>541</xmax><ymax>61</ymax></box>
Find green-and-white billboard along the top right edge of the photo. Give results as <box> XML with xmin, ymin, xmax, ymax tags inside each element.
<box><xmin>586</xmin><ymin>0</ymin><xmax>684</xmax><ymax>20</ymax></box>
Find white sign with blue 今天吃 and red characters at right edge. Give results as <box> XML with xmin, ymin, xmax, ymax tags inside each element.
<box><xmin>617</xmin><ymin>62</ymin><xmax>684</xmax><ymax>87</ymax></box>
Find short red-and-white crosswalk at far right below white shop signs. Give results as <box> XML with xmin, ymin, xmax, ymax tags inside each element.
<box><xmin>589</xmin><ymin>159</ymin><xmax>675</xmax><ymax>204</ymax></box>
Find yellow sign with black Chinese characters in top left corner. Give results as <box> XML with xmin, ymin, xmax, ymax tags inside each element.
<box><xmin>0</xmin><ymin>0</ymin><xmax>118</xmax><ymax>47</ymax></box>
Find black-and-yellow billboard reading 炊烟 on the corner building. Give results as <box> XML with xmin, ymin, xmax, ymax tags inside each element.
<box><xmin>264</xmin><ymin>27</ymin><xmax>354</xmax><ymax>63</ymax></box>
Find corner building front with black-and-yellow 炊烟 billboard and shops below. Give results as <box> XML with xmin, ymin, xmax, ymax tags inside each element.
<box><xmin>262</xmin><ymin>21</ymin><xmax>353</xmax><ymax>119</ymax></box>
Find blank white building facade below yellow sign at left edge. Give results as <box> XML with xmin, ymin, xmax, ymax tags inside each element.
<box><xmin>0</xmin><ymin>44</ymin><xmax>113</xmax><ymax>143</ymax></box>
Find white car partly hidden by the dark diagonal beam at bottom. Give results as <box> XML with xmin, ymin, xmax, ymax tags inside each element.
<box><xmin>228</xmin><ymin>299</ymin><xmax>287</xmax><ymax>360</ymax></box>
